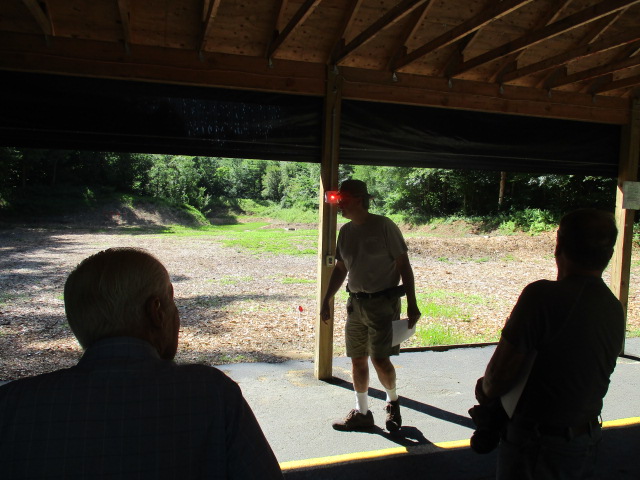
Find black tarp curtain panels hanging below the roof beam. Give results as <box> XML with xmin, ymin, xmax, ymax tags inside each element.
<box><xmin>0</xmin><ymin>71</ymin><xmax>620</xmax><ymax>177</ymax></box>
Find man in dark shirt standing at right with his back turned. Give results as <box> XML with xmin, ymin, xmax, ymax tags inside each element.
<box><xmin>476</xmin><ymin>209</ymin><xmax>624</xmax><ymax>479</ymax></box>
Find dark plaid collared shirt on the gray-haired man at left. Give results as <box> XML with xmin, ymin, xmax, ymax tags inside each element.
<box><xmin>0</xmin><ymin>337</ymin><xmax>282</xmax><ymax>480</ymax></box>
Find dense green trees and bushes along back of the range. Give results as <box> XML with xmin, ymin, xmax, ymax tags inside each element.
<box><xmin>0</xmin><ymin>148</ymin><xmax>616</xmax><ymax>226</ymax></box>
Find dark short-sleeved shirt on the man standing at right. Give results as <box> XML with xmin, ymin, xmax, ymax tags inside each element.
<box><xmin>502</xmin><ymin>276</ymin><xmax>624</xmax><ymax>426</ymax></box>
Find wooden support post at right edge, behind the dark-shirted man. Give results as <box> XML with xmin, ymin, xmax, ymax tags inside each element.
<box><xmin>611</xmin><ymin>99</ymin><xmax>640</xmax><ymax>354</ymax></box>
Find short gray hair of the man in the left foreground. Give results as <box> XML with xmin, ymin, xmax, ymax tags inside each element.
<box><xmin>64</xmin><ymin>248</ymin><xmax>170</xmax><ymax>348</ymax></box>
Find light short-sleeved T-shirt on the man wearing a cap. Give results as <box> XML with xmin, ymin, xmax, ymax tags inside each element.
<box><xmin>336</xmin><ymin>214</ymin><xmax>407</xmax><ymax>293</ymax></box>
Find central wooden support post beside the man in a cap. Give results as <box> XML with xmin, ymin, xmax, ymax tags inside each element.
<box><xmin>314</xmin><ymin>67</ymin><xmax>342</xmax><ymax>380</ymax></box>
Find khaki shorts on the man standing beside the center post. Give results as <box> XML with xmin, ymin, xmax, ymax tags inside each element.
<box><xmin>345</xmin><ymin>296</ymin><xmax>400</xmax><ymax>358</ymax></box>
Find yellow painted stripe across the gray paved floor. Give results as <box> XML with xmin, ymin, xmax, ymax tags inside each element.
<box><xmin>280</xmin><ymin>417</ymin><xmax>640</xmax><ymax>470</ymax></box>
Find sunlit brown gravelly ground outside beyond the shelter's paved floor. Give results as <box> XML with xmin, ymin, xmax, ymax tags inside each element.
<box><xmin>0</xmin><ymin>212</ymin><xmax>640</xmax><ymax>380</ymax></box>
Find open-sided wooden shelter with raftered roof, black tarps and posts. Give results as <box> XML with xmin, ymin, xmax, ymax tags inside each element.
<box><xmin>0</xmin><ymin>0</ymin><xmax>640</xmax><ymax>379</ymax></box>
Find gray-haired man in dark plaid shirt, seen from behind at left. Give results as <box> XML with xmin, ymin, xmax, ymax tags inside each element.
<box><xmin>0</xmin><ymin>248</ymin><xmax>282</xmax><ymax>480</ymax></box>
